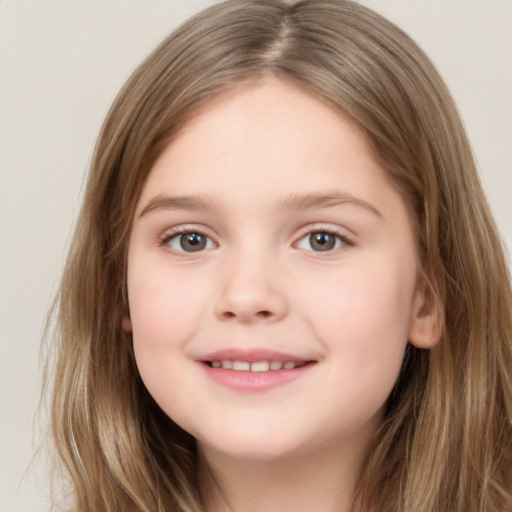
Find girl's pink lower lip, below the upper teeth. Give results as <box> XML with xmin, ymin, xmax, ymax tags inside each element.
<box><xmin>201</xmin><ymin>363</ymin><xmax>314</xmax><ymax>392</ymax></box>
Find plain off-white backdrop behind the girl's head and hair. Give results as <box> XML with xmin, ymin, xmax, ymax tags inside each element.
<box><xmin>0</xmin><ymin>0</ymin><xmax>512</xmax><ymax>512</ymax></box>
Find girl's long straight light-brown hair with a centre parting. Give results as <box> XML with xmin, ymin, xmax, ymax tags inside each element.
<box><xmin>52</xmin><ymin>0</ymin><xmax>512</xmax><ymax>512</ymax></box>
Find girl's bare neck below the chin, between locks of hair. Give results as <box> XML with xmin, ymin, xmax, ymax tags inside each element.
<box><xmin>200</xmin><ymin>436</ymin><xmax>365</xmax><ymax>512</ymax></box>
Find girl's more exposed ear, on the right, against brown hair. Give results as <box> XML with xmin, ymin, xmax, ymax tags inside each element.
<box><xmin>409</xmin><ymin>278</ymin><xmax>444</xmax><ymax>349</ymax></box>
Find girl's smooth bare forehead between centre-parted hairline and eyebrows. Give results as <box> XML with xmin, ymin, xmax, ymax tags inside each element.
<box><xmin>137</xmin><ymin>80</ymin><xmax>396</xmax><ymax>208</ymax></box>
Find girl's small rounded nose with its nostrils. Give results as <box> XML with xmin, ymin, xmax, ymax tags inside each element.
<box><xmin>215</xmin><ymin>249</ymin><xmax>288</xmax><ymax>324</ymax></box>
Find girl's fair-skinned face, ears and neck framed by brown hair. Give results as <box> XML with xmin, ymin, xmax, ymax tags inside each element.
<box><xmin>124</xmin><ymin>80</ymin><xmax>436</xmax><ymax>512</ymax></box>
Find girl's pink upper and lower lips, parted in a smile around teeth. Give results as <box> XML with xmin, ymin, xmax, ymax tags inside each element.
<box><xmin>198</xmin><ymin>349</ymin><xmax>316</xmax><ymax>392</ymax></box>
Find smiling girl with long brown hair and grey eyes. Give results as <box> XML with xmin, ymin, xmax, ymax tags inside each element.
<box><xmin>53</xmin><ymin>0</ymin><xmax>512</xmax><ymax>512</ymax></box>
